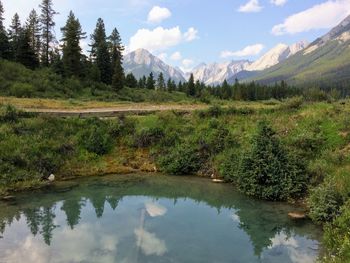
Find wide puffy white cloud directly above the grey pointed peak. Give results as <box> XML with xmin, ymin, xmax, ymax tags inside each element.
<box><xmin>128</xmin><ymin>26</ymin><xmax>197</xmax><ymax>52</ymax></box>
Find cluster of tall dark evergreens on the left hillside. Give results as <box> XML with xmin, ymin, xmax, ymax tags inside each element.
<box><xmin>0</xmin><ymin>0</ymin><xmax>124</xmax><ymax>90</ymax></box>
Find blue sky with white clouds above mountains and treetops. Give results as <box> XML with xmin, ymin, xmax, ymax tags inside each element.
<box><xmin>0</xmin><ymin>0</ymin><xmax>350</xmax><ymax>71</ymax></box>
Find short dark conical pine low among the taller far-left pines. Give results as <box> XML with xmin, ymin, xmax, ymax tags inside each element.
<box><xmin>16</xmin><ymin>29</ymin><xmax>39</xmax><ymax>69</ymax></box>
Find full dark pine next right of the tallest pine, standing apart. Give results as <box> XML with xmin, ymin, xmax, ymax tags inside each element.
<box><xmin>61</xmin><ymin>11</ymin><xmax>85</xmax><ymax>77</ymax></box>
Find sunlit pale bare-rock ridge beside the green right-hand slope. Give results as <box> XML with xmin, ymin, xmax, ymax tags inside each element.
<box><xmin>245</xmin><ymin>41</ymin><xmax>308</xmax><ymax>71</ymax></box>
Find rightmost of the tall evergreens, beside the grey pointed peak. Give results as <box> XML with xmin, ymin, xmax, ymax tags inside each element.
<box><xmin>108</xmin><ymin>28</ymin><xmax>125</xmax><ymax>90</ymax></box>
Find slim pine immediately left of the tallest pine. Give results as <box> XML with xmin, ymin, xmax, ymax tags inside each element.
<box><xmin>26</xmin><ymin>9</ymin><xmax>41</xmax><ymax>63</ymax></box>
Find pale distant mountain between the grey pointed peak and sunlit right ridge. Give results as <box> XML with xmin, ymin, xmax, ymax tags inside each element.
<box><xmin>192</xmin><ymin>60</ymin><xmax>251</xmax><ymax>85</ymax></box>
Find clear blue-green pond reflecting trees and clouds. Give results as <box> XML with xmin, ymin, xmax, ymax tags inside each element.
<box><xmin>0</xmin><ymin>175</ymin><xmax>321</xmax><ymax>263</ymax></box>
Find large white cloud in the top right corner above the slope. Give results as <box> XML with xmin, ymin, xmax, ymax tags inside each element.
<box><xmin>272</xmin><ymin>0</ymin><xmax>350</xmax><ymax>35</ymax></box>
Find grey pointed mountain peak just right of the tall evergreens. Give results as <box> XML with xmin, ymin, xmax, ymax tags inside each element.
<box><xmin>123</xmin><ymin>49</ymin><xmax>185</xmax><ymax>82</ymax></box>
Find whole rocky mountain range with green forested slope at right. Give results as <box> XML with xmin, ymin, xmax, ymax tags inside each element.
<box><xmin>124</xmin><ymin>16</ymin><xmax>350</xmax><ymax>85</ymax></box>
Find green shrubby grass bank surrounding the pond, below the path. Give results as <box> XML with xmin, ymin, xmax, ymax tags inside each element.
<box><xmin>0</xmin><ymin>98</ymin><xmax>350</xmax><ymax>262</ymax></box>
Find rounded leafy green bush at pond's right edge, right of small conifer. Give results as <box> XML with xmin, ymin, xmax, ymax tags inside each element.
<box><xmin>308</xmin><ymin>182</ymin><xmax>343</xmax><ymax>223</ymax></box>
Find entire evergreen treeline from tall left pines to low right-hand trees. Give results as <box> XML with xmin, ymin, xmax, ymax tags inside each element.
<box><xmin>0</xmin><ymin>0</ymin><xmax>349</xmax><ymax>102</ymax></box>
